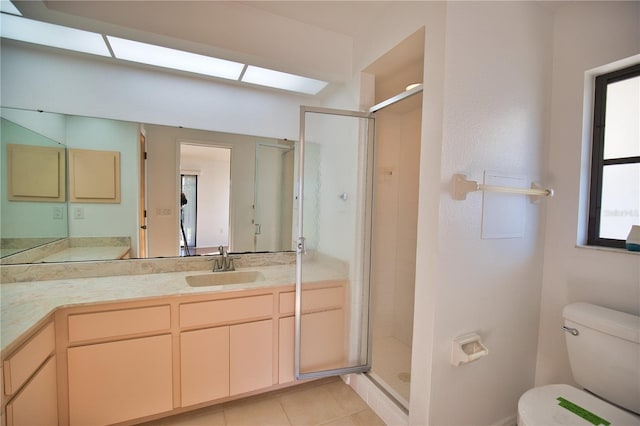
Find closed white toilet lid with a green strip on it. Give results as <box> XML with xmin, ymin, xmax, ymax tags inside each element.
<box><xmin>518</xmin><ymin>385</ymin><xmax>640</xmax><ymax>426</ymax></box>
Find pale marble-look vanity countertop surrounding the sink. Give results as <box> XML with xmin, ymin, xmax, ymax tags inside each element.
<box><xmin>0</xmin><ymin>262</ymin><xmax>346</xmax><ymax>350</ymax></box>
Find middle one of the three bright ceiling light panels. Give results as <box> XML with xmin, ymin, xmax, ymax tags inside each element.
<box><xmin>107</xmin><ymin>36</ymin><xmax>244</xmax><ymax>80</ymax></box>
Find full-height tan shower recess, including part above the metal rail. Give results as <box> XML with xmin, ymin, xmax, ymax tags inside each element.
<box><xmin>364</xmin><ymin>28</ymin><xmax>425</xmax><ymax>413</ymax></box>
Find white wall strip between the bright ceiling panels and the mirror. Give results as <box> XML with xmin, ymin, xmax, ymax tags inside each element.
<box><xmin>0</xmin><ymin>43</ymin><xmax>317</xmax><ymax>140</ymax></box>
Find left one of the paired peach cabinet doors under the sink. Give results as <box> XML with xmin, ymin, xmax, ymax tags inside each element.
<box><xmin>180</xmin><ymin>327</ymin><xmax>229</xmax><ymax>407</ymax></box>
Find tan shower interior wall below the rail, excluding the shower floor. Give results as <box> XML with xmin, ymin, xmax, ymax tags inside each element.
<box><xmin>373</xmin><ymin>101</ymin><xmax>422</xmax><ymax>347</ymax></box>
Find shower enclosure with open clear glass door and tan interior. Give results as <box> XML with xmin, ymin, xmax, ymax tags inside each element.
<box><xmin>295</xmin><ymin>85</ymin><xmax>422</xmax><ymax>409</ymax></box>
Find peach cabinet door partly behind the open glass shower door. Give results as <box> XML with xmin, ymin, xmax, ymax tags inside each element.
<box><xmin>278</xmin><ymin>309</ymin><xmax>345</xmax><ymax>383</ymax></box>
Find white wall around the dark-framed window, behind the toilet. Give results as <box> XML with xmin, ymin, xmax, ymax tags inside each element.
<box><xmin>536</xmin><ymin>2</ymin><xmax>640</xmax><ymax>385</ymax></box>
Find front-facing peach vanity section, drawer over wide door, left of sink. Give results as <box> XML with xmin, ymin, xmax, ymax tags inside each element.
<box><xmin>67</xmin><ymin>305</ymin><xmax>173</xmax><ymax>425</ymax></box>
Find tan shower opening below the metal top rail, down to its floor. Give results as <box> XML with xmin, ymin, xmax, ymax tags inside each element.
<box><xmin>369</xmin><ymin>94</ymin><xmax>422</xmax><ymax>409</ymax></box>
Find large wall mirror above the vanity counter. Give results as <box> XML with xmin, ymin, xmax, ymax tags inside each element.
<box><xmin>0</xmin><ymin>108</ymin><xmax>297</xmax><ymax>263</ymax></box>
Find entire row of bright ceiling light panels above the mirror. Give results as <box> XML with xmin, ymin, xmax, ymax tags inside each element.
<box><xmin>0</xmin><ymin>12</ymin><xmax>328</xmax><ymax>95</ymax></box>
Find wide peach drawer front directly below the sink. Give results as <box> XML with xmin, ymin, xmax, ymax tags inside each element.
<box><xmin>180</xmin><ymin>294</ymin><xmax>273</xmax><ymax>327</ymax></box>
